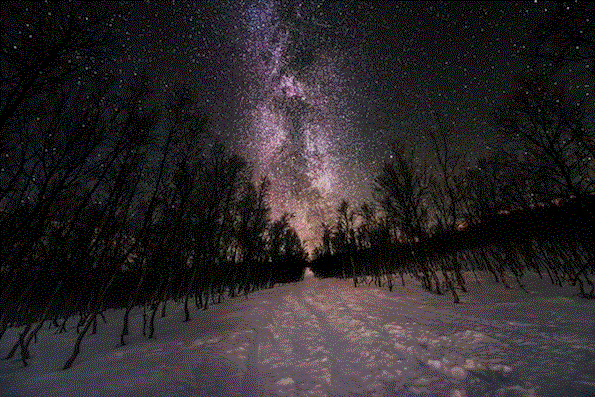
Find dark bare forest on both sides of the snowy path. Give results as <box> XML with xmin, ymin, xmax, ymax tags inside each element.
<box><xmin>0</xmin><ymin>3</ymin><xmax>595</xmax><ymax>369</ymax></box>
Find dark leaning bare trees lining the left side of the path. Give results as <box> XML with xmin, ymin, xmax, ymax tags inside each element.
<box><xmin>0</xmin><ymin>2</ymin><xmax>306</xmax><ymax>369</ymax></box>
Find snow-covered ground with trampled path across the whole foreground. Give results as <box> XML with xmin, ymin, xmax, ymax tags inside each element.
<box><xmin>0</xmin><ymin>273</ymin><xmax>595</xmax><ymax>397</ymax></box>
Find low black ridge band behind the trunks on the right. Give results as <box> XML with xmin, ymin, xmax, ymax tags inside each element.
<box><xmin>310</xmin><ymin>196</ymin><xmax>595</xmax><ymax>303</ymax></box>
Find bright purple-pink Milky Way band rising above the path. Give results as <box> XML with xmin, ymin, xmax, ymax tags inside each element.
<box><xmin>240</xmin><ymin>1</ymin><xmax>351</xmax><ymax>248</ymax></box>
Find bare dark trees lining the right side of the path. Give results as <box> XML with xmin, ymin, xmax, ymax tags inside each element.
<box><xmin>311</xmin><ymin>3</ymin><xmax>595</xmax><ymax>302</ymax></box>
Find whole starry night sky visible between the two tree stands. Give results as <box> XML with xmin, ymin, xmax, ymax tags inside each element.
<box><xmin>107</xmin><ymin>0</ymin><xmax>553</xmax><ymax>246</ymax></box>
